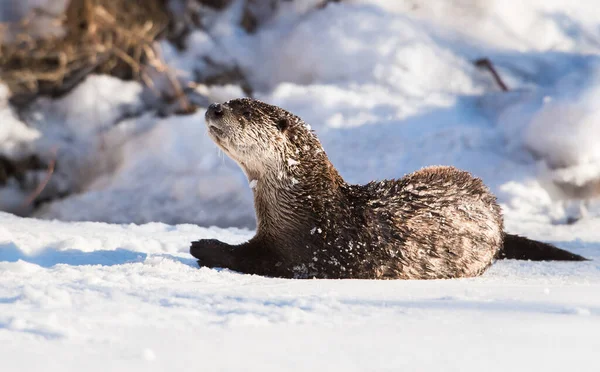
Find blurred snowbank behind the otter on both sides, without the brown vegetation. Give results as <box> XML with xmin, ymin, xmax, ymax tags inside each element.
<box><xmin>2</xmin><ymin>0</ymin><xmax>600</xmax><ymax>227</ymax></box>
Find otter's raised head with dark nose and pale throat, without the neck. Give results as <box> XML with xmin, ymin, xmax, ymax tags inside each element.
<box><xmin>205</xmin><ymin>98</ymin><xmax>324</xmax><ymax>180</ymax></box>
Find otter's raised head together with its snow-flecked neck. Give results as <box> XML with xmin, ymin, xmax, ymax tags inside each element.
<box><xmin>206</xmin><ymin>98</ymin><xmax>343</xmax><ymax>235</ymax></box>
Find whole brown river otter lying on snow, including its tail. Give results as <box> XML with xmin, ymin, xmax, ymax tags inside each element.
<box><xmin>190</xmin><ymin>98</ymin><xmax>585</xmax><ymax>279</ymax></box>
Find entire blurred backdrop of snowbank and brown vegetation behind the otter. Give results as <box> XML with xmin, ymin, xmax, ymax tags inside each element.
<box><xmin>0</xmin><ymin>0</ymin><xmax>600</xmax><ymax>230</ymax></box>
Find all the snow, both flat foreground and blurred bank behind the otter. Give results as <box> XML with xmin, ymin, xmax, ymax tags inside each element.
<box><xmin>0</xmin><ymin>0</ymin><xmax>600</xmax><ymax>371</ymax></box>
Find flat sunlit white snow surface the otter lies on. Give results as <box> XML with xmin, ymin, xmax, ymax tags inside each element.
<box><xmin>0</xmin><ymin>213</ymin><xmax>600</xmax><ymax>371</ymax></box>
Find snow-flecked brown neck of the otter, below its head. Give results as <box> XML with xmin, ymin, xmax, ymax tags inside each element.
<box><xmin>249</xmin><ymin>158</ymin><xmax>345</xmax><ymax>241</ymax></box>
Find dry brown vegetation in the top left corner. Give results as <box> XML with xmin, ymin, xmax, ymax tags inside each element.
<box><xmin>0</xmin><ymin>0</ymin><xmax>169</xmax><ymax>102</ymax></box>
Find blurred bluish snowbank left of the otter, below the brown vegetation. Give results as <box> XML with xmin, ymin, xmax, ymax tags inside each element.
<box><xmin>0</xmin><ymin>75</ymin><xmax>254</xmax><ymax>226</ymax></box>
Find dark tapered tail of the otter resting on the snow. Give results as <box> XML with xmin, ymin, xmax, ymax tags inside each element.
<box><xmin>497</xmin><ymin>233</ymin><xmax>588</xmax><ymax>261</ymax></box>
